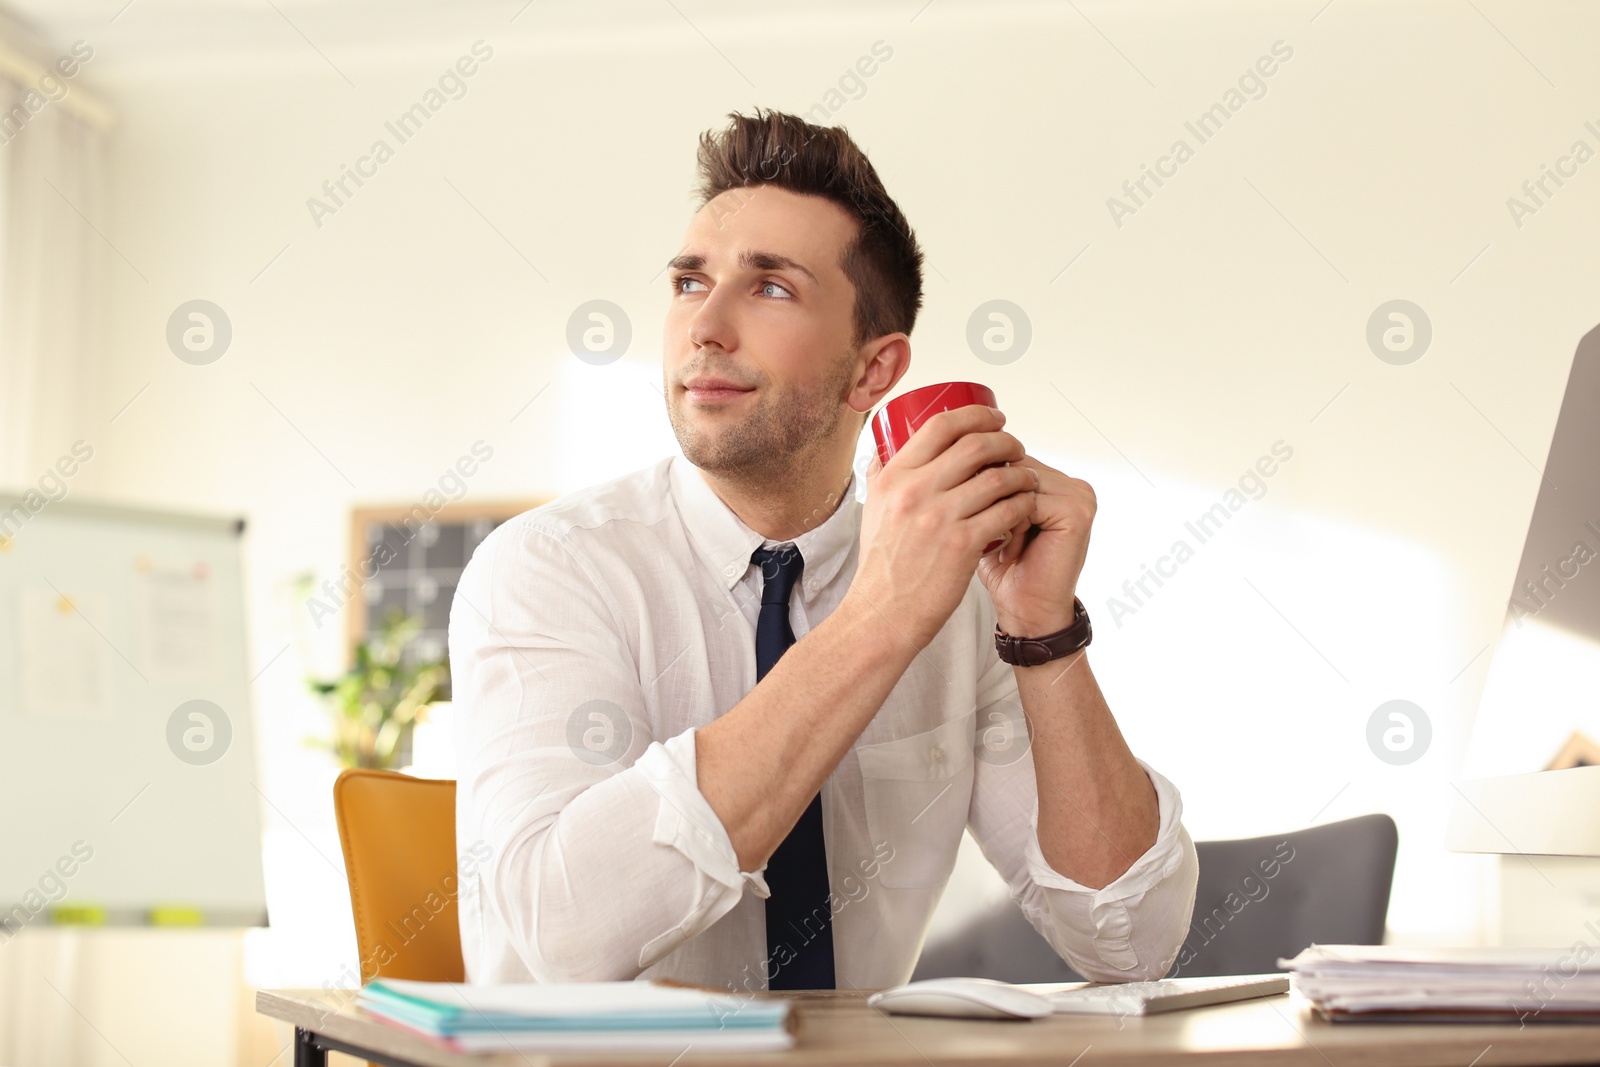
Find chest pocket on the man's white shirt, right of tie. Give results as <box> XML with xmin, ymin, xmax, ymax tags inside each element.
<box><xmin>856</xmin><ymin>717</ymin><xmax>973</xmax><ymax>889</ymax></box>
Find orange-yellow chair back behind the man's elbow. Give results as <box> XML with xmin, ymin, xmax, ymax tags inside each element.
<box><xmin>333</xmin><ymin>769</ymin><xmax>466</xmax><ymax>984</ymax></box>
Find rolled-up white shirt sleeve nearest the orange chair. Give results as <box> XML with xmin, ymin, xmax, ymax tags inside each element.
<box><xmin>450</xmin><ymin>518</ymin><xmax>766</xmax><ymax>982</ymax></box>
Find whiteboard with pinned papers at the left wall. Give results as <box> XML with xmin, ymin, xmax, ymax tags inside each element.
<box><xmin>0</xmin><ymin>493</ymin><xmax>266</xmax><ymax>941</ymax></box>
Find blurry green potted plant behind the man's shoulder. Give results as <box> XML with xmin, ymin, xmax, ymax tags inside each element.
<box><xmin>309</xmin><ymin>611</ymin><xmax>450</xmax><ymax>771</ymax></box>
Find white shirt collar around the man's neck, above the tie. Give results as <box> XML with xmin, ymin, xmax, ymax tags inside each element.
<box><xmin>669</xmin><ymin>456</ymin><xmax>861</xmax><ymax>592</ymax></box>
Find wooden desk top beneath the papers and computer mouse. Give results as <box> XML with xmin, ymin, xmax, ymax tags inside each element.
<box><xmin>256</xmin><ymin>990</ymin><xmax>1600</xmax><ymax>1067</ymax></box>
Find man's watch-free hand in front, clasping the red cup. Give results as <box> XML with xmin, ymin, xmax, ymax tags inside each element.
<box><xmin>846</xmin><ymin>405</ymin><xmax>1038</xmax><ymax>649</ymax></box>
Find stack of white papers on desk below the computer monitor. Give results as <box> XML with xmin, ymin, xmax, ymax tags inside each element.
<box><xmin>1278</xmin><ymin>941</ymin><xmax>1600</xmax><ymax>1022</ymax></box>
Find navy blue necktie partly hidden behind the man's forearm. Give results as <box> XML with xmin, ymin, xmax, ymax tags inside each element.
<box><xmin>750</xmin><ymin>544</ymin><xmax>834</xmax><ymax>989</ymax></box>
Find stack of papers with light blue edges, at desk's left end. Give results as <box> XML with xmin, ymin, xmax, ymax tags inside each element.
<box><xmin>357</xmin><ymin>979</ymin><xmax>794</xmax><ymax>1053</ymax></box>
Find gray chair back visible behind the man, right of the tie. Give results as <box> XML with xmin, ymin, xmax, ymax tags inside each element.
<box><xmin>912</xmin><ymin>814</ymin><xmax>1400</xmax><ymax>982</ymax></box>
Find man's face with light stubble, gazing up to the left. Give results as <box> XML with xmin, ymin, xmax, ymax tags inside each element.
<box><xmin>662</xmin><ymin>186</ymin><xmax>861</xmax><ymax>478</ymax></box>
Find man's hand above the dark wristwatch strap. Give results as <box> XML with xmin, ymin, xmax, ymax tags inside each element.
<box><xmin>978</xmin><ymin>456</ymin><xmax>1096</xmax><ymax>637</ymax></box>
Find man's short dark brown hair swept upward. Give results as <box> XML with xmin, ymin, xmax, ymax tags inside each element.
<box><xmin>696</xmin><ymin>107</ymin><xmax>922</xmax><ymax>344</ymax></box>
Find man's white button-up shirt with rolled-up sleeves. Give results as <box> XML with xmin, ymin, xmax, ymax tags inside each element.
<box><xmin>450</xmin><ymin>456</ymin><xmax>1198</xmax><ymax>990</ymax></box>
